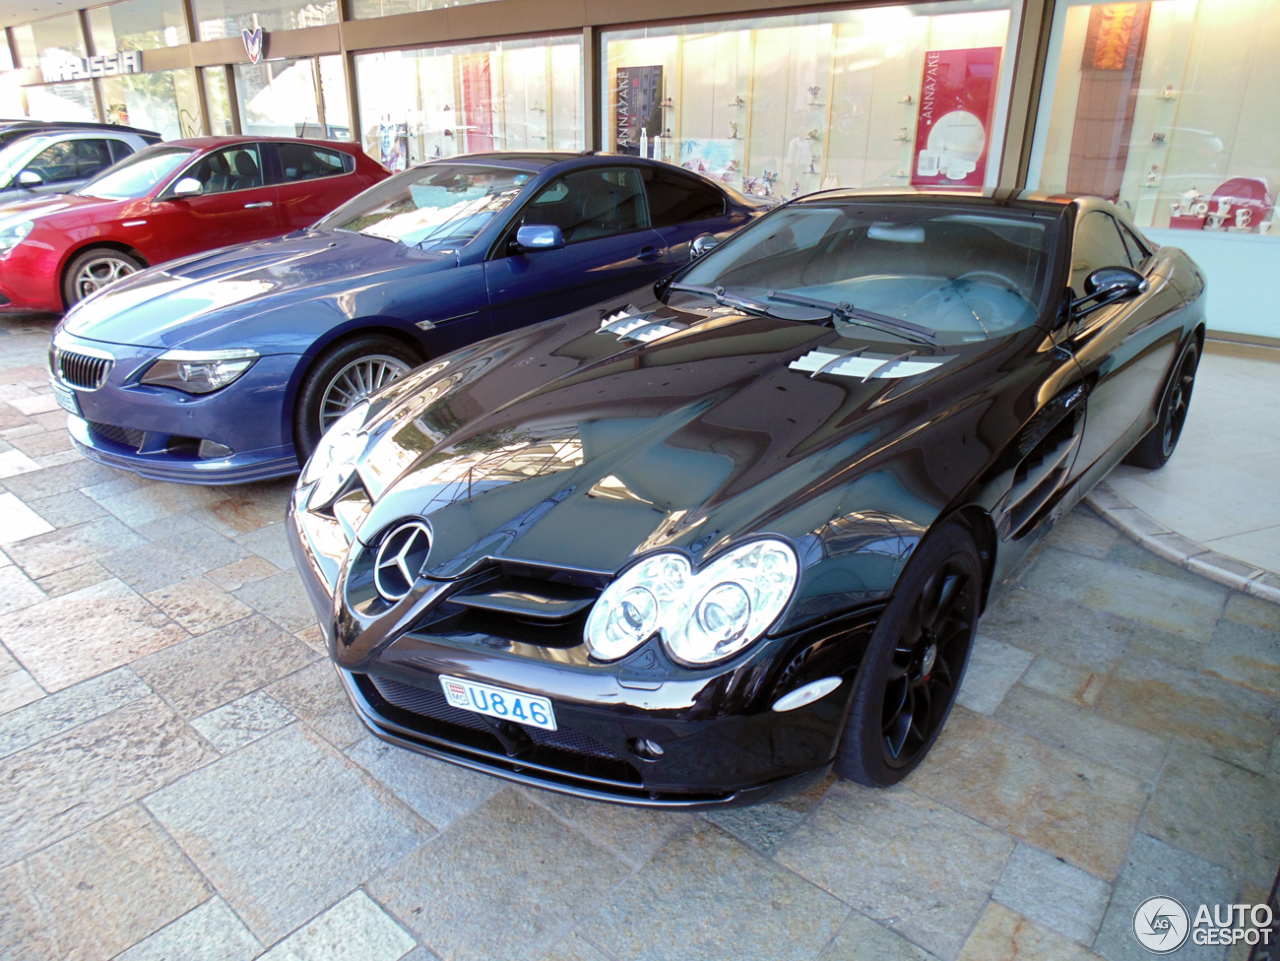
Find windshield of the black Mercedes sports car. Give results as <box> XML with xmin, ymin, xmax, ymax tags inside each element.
<box><xmin>671</xmin><ymin>202</ymin><xmax>1057</xmax><ymax>343</ymax></box>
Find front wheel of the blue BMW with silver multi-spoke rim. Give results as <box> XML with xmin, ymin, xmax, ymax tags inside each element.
<box><xmin>293</xmin><ymin>334</ymin><xmax>422</xmax><ymax>463</ymax></box>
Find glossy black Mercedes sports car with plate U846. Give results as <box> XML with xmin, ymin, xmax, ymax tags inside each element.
<box><xmin>289</xmin><ymin>192</ymin><xmax>1204</xmax><ymax>807</ymax></box>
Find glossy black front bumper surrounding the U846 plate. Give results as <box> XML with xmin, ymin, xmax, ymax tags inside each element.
<box><xmin>289</xmin><ymin>506</ymin><xmax>878</xmax><ymax>809</ymax></box>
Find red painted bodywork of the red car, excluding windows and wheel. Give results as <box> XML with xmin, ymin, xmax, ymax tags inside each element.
<box><xmin>0</xmin><ymin>137</ymin><xmax>390</xmax><ymax>314</ymax></box>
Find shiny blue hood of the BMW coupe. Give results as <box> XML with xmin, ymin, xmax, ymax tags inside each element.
<box><xmin>63</xmin><ymin>230</ymin><xmax>458</xmax><ymax>348</ymax></box>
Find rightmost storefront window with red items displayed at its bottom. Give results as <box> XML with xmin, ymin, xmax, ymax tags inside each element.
<box><xmin>1030</xmin><ymin>0</ymin><xmax>1280</xmax><ymax>237</ymax></box>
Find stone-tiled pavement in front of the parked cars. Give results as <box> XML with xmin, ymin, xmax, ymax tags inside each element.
<box><xmin>0</xmin><ymin>309</ymin><xmax>1280</xmax><ymax>961</ymax></box>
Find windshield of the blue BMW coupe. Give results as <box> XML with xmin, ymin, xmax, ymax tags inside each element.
<box><xmin>325</xmin><ymin>164</ymin><xmax>532</xmax><ymax>251</ymax></box>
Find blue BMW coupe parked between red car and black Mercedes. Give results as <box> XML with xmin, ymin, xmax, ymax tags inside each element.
<box><xmin>50</xmin><ymin>154</ymin><xmax>765</xmax><ymax>484</ymax></box>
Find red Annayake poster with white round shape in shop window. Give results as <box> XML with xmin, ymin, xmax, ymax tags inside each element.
<box><xmin>911</xmin><ymin>47</ymin><xmax>1001</xmax><ymax>187</ymax></box>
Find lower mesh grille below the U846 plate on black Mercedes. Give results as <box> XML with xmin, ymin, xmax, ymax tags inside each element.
<box><xmin>369</xmin><ymin>674</ymin><xmax>640</xmax><ymax>783</ymax></box>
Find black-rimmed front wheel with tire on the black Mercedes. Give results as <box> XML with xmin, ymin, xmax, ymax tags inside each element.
<box><xmin>835</xmin><ymin>523</ymin><xmax>982</xmax><ymax>787</ymax></box>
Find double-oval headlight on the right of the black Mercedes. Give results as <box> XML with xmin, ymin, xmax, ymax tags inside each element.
<box><xmin>585</xmin><ymin>540</ymin><xmax>799</xmax><ymax>665</ymax></box>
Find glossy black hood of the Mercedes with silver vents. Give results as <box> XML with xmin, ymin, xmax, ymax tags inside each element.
<box><xmin>345</xmin><ymin>305</ymin><xmax>1046</xmax><ymax>578</ymax></box>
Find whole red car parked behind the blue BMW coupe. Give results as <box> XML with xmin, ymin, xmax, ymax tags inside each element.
<box><xmin>0</xmin><ymin>137</ymin><xmax>390</xmax><ymax>312</ymax></box>
